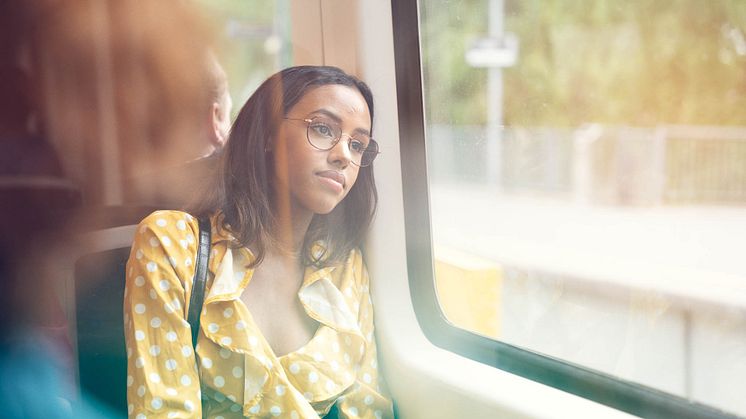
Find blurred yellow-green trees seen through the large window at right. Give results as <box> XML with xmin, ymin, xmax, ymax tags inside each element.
<box><xmin>421</xmin><ymin>0</ymin><xmax>746</xmax><ymax>127</ymax></box>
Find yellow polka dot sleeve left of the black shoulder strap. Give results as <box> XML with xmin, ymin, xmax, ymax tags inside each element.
<box><xmin>124</xmin><ymin>211</ymin><xmax>201</xmax><ymax>419</ymax></box>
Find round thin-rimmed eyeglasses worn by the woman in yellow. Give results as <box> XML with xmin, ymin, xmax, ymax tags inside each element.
<box><xmin>284</xmin><ymin>116</ymin><xmax>379</xmax><ymax>167</ymax></box>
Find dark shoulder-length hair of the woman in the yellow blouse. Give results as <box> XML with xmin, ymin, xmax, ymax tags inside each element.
<box><xmin>191</xmin><ymin>66</ymin><xmax>378</xmax><ymax>266</ymax></box>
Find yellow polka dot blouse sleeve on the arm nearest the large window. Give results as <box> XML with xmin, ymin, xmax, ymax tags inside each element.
<box><xmin>337</xmin><ymin>252</ymin><xmax>394</xmax><ymax>419</ymax></box>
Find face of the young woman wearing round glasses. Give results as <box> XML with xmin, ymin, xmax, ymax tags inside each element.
<box><xmin>272</xmin><ymin>84</ymin><xmax>371</xmax><ymax>218</ymax></box>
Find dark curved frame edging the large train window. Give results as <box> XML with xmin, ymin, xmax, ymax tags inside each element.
<box><xmin>391</xmin><ymin>0</ymin><xmax>736</xmax><ymax>418</ymax></box>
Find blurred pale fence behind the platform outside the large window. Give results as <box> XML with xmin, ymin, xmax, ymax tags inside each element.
<box><xmin>428</xmin><ymin>124</ymin><xmax>746</xmax><ymax>205</ymax></box>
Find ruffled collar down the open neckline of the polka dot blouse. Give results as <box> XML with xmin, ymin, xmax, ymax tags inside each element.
<box><xmin>200</xmin><ymin>216</ymin><xmax>365</xmax><ymax>415</ymax></box>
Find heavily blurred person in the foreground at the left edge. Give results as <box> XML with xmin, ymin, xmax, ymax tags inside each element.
<box><xmin>0</xmin><ymin>0</ymin><xmax>221</xmax><ymax>418</ymax></box>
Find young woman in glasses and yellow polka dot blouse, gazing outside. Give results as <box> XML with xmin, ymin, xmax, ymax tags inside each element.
<box><xmin>124</xmin><ymin>66</ymin><xmax>393</xmax><ymax>418</ymax></box>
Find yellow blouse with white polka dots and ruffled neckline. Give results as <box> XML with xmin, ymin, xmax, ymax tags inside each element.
<box><xmin>124</xmin><ymin>211</ymin><xmax>393</xmax><ymax>419</ymax></box>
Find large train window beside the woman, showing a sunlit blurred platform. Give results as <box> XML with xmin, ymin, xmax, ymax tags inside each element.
<box><xmin>392</xmin><ymin>0</ymin><xmax>746</xmax><ymax>417</ymax></box>
